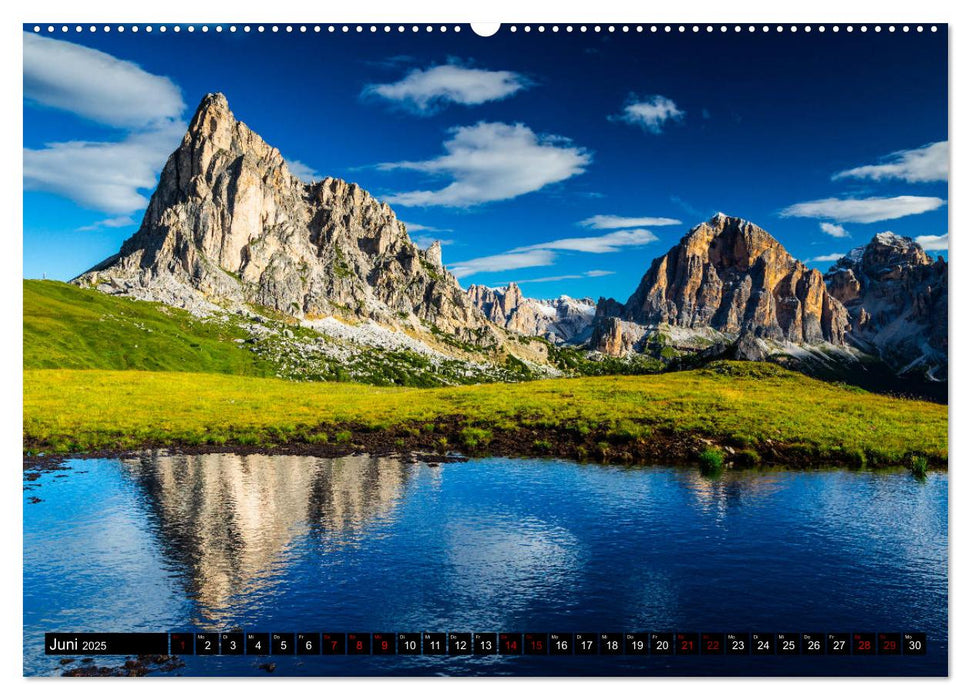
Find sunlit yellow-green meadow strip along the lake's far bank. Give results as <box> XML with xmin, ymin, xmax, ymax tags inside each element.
<box><xmin>24</xmin><ymin>362</ymin><xmax>947</xmax><ymax>465</ymax></box>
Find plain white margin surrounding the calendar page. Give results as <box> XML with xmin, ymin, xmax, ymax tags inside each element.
<box><xmin>0</xmin><ymin>0</ymin><xmax>971</xmax><ymax>700</ymax></box>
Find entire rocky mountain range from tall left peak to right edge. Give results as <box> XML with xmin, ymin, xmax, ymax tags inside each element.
<box><xmin>73</xmin><ymin>94</ymin><xmax>947</xmax><ymax>398</ymax></box>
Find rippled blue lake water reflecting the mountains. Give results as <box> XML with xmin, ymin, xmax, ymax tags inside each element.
<box><xmin>24</xmin><ymin>454</ymin><xmax>947</xmax><ymax>675</ymax></box>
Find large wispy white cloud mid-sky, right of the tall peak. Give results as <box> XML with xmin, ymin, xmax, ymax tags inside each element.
<box><xmin>378</xmin><ymin>122</ymin><xmax>591</xmax><ymax>207</ymax></box>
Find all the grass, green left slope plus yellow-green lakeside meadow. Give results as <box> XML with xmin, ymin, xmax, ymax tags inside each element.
<box><xmin>23</xmin><ymin>281</ymin><xmax>947</xmax><ymax>465</ymax></box>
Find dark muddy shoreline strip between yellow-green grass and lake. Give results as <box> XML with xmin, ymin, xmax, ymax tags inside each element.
<box><xmin>23</xmin><ymin>416</ymin><xmax>947</xmax><ymax>470</ymax></box>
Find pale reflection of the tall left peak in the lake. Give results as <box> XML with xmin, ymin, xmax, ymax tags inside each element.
<box><xmin>124</xmin><ymin>454</ymin><xmax>408</xmax><ymax>629</ymax></box>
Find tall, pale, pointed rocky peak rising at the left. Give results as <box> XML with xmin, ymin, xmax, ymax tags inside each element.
<box><xmin>75</xmin><ymin>93</ymin><xmax>498</xmax><ymax>344</ymax></box>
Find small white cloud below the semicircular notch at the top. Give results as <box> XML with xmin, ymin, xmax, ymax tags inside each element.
<box><xmin>362</xmin><ymin>64</ymin><xmax>529</xmax><ymax>114</ymax></box>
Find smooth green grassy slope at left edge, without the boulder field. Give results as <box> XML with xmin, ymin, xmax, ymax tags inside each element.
<box><xmin>24</xmin><ymin>280</ymin><xmax>273</xmax><ymax>376</ymax></box>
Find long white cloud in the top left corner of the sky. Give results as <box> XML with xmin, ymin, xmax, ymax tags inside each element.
<box><xmin>23</xmin><ymin>32</ymin><xmax>185</xmax><ymax>129</ymax></box>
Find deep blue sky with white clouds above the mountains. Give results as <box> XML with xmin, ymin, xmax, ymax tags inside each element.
<box><xmin>24</xmin><ymin>26</ymin><xmax>948</xmax><ymax>300</ymax></box>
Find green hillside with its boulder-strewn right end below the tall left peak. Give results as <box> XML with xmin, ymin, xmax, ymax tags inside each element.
<box><xmin>24</xmin><ymin>280</ymin><xmax>536</xmax><ymax>386</ymax></box>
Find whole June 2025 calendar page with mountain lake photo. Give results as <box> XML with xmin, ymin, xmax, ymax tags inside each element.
<box><xmin>21</xmin><ymin>22</ymin><xmax>949</xmax><ymax>677</ymax></box>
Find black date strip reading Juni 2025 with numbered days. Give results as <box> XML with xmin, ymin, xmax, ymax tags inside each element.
<box><xmin>44</xmin><ymin>632</ymin><xmax>927</xmax><ymax>656</ymax></box>
